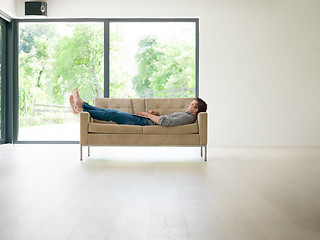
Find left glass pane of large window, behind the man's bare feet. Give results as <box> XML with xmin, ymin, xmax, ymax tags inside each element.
<box><xmin>18</xmin><ymin>23</ymin><xmax>104</xmax><ymax>141</ymax></box>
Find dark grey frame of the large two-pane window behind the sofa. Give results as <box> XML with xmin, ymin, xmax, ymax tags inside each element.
<box><xmin>12</xmin><ymin>18</ymin><xmax>199</xmax><ymax>144</ymax></box>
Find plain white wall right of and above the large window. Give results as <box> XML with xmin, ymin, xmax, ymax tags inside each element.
<box><xmin>16</xmin><ymin>0</ymin><xmax>320</xmax><ymax>146</ymax></box>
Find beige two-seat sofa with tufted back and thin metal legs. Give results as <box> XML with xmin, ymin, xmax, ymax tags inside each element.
<box><xmin>80</xmin><ymin>98</ymin><xmax>207</xmax><ymax>161</ymax></box>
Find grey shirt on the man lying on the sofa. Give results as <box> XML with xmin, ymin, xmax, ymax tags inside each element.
<box><xmin>159</xmin><ymin>112</ymin><xmax>197</xmax><ymax>127</ymax></box>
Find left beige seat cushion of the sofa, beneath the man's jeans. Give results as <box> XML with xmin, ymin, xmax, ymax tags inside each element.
<box><xmin>89</xmin><ymin>123</ymin><xmax>142</xmax><ymax>134</ymax></box>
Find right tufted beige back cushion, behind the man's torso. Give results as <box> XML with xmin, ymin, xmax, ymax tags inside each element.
<box><xmin>145</xmin><ymin>98</ymin><xmax>194</xmax><ymax>115</ymax></box>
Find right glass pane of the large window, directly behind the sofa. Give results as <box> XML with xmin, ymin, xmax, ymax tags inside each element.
<box><xmin>110</xmin><ymin>22</ymin><xmax>196</xmax><ymax>98</ymax></box>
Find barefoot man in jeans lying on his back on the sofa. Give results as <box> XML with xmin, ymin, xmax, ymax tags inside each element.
<box><xmin>70</xmin><ymin>88</ymin><xmax>207</xmax><ymax>127</ymax></box>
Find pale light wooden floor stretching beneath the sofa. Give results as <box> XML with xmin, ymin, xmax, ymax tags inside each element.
<box><xmin>0</xmin><ymin>145</ymin><xmax>320</xmax><ymax>240</ymax></box>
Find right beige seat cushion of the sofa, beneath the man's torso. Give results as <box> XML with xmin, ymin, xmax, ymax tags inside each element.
<box><xmin>142</xmin><ymin>123</ymin><xmax>199</xmax><ymax>135</ymax></box>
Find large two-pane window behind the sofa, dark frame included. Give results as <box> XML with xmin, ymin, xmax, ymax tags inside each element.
<box><xmin>18</xmin><ymin>19</ymin><xmax>198</xmax><ymax>141</ymax></box>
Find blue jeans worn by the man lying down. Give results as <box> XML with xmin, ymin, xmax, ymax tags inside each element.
<box><xmin>82</xmin><ymin>102</ymin><xmax>152</xmax><ymax>126</ymax></box>
